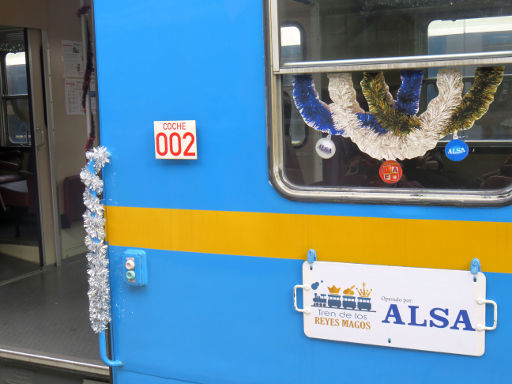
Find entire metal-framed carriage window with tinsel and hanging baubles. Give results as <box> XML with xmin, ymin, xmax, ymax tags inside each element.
<box><xmin>267</xmin><ymin>0</ymin><xmax>512</xmax><ymax>205</ymax></box>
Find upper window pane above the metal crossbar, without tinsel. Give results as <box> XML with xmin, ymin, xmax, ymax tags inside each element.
<box><xmin>277</xmin><ymin>0</ymin><xmax>511</xmax><ymax>64</ymax></box>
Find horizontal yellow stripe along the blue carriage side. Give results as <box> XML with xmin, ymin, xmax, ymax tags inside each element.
<box><xmin>105</xmin><ymin>207</ymin><xmax>512</xmax><ymax>273</ymax></box>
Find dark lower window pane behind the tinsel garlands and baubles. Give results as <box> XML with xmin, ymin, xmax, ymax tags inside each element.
<box><xmin>282</xmin><ymin>68</ymin><xmax>512</xmax><ymax>190</ymax></box>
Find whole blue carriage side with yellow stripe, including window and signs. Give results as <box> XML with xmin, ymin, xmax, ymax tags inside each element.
<box><xmin>92</xmin><ymin>0</ymin><xmax>512</xmax><ymax>384</ymax></box>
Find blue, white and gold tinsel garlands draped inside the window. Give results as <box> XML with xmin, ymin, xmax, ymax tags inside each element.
<box><xmin>293</xmin><ymin>67</ymin><xmax>503</xmax><ymax>160</ymax></box>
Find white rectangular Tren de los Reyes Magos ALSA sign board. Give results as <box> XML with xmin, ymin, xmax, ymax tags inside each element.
<box><xmin>302</xmin><ymin>261</ymin><xmax>486</xmax><ymax>356</ymax></box>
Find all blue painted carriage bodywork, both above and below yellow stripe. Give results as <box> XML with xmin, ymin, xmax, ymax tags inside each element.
<box><xmin>95</xmin><ymin>0</ymin><xmax>512</xmax><ymax>384</ymax></box>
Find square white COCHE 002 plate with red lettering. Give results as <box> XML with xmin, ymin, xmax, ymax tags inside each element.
<box><xmin>154</xmin><ymin>120</ymin><xmax>197</xmax><ymax>160</ymax></box>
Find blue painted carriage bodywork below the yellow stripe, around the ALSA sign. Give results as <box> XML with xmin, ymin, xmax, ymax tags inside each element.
<box><xmin>110</xmin><ymin>247</ymin><xmax>512</xmax><ymax>384</ymax></box>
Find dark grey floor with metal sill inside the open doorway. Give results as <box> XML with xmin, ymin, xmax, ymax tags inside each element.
<box><xmin>0</xmin><ymin>256</ymin><xmax>109</xmax><ymax>376</ymax></box>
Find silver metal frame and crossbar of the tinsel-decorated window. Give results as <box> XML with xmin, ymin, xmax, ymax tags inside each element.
<box><xmin>264</xmin><ymin>0</ymin><xmax>512</xmax><ymax>206</ymax></box>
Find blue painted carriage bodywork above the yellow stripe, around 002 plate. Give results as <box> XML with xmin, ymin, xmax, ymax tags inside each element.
<box><xmin>95</xmin><ymin>0</ymin><xmax>512</xmax><ymax>222</ymax></box>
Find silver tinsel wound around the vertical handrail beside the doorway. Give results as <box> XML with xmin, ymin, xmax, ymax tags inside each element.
<box><xmin>80</xmin><ymin>147</ymin><xmax>111</xmax><ymax>333</ymax></box>
